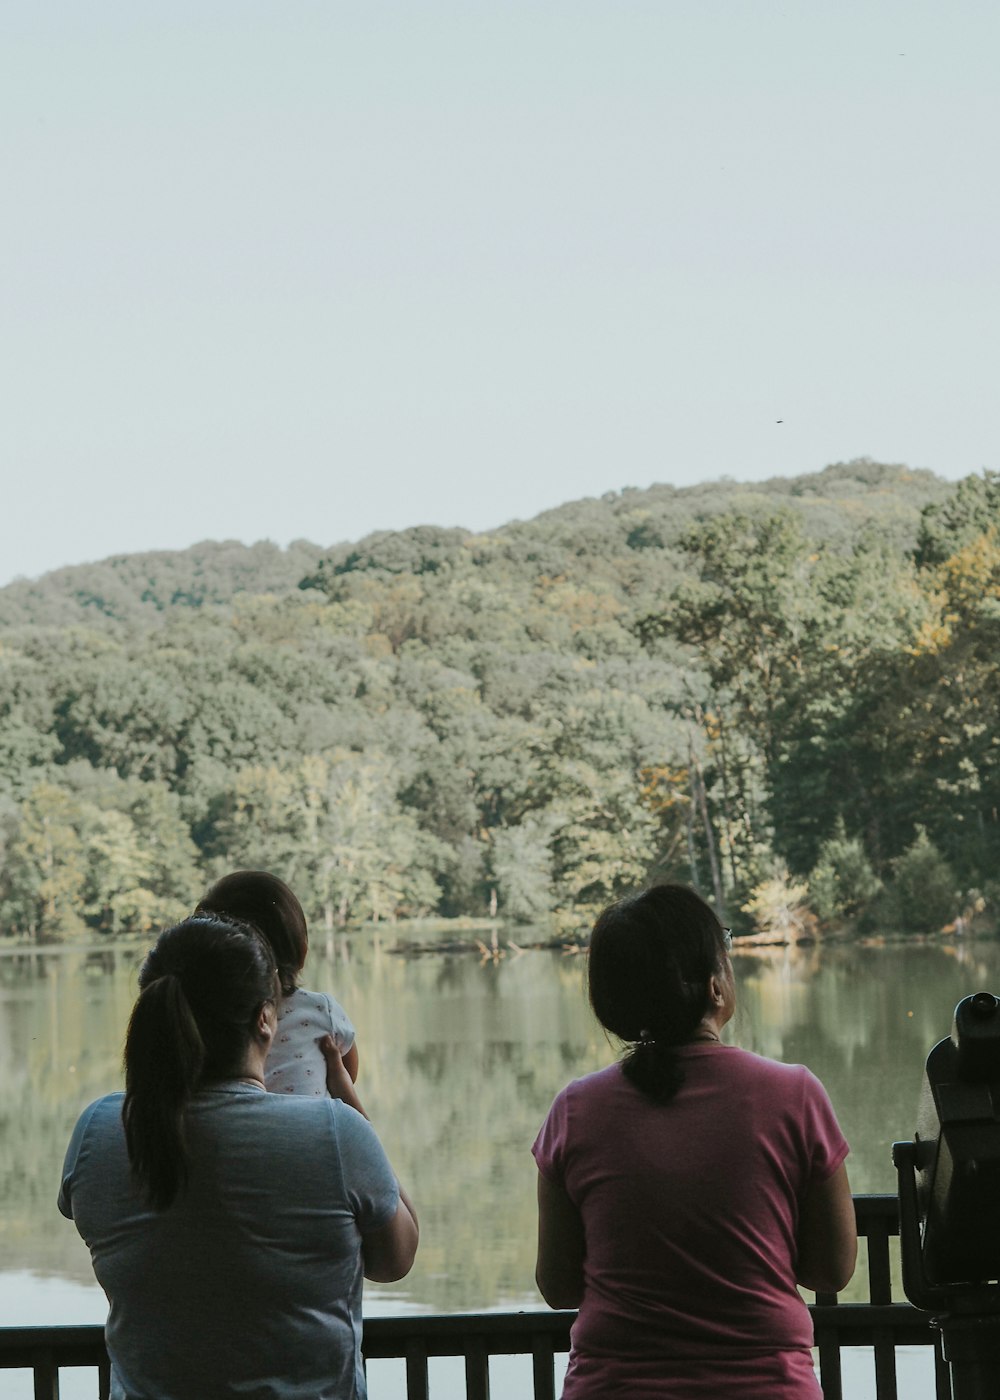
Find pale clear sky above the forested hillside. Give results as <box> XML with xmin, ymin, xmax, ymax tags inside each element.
<box><xmin>0</xmin><ymin>0</ymin><xmax>1000</xmax><ymax>582</ymax></box>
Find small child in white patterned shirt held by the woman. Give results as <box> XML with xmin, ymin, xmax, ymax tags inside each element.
<box><xmin>195</xmin><ymin>871</ymin><xmax>357</xmax><ymax>1098</ymax></box>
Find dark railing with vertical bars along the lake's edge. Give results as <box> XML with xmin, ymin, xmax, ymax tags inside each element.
<box><xmin>0</xmin><ymin>1196</ymin><xmax>951</xmax><ymax>1400</ymax></box>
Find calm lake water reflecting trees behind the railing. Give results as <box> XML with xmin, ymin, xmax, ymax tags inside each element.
<box><xmin>0</xmin><ymin>934</ymin><xmax>1000</xmax><ymax>1400</ymax></box>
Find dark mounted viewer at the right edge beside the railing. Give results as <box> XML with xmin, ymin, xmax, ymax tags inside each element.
<box><xmin>892</xmin><ymin>991</ymin><xmax>1000</xmax><ymax>1400</ymax></box>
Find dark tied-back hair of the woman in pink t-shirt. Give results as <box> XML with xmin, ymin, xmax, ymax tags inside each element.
<box><xmin>588</xmin><ymin>885</ymin><xmax>725</xmax><ymax>1102</ymax></box>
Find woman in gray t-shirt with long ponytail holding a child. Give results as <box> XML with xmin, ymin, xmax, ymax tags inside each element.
<box><xmin>59</xmin><ymin>916</ymin><xmax>417</xmax><ymax>1400</ymax></box>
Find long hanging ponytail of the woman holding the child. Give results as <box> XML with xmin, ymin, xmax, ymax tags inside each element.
<box><xmin>122</xmin><ymin>973</ymin><xmax>204</xmax><ymax>1210</ymax></box>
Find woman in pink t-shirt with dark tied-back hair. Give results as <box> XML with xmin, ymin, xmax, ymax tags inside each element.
<box><xmin>532</xmin><ymin>885</ymin><xmax>857</xmax><ymax>1400</ymax></box>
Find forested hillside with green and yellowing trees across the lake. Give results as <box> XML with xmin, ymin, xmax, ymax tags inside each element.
<box><xmin>0</xmin><ymin>461</ymin><xmax>1000</xmax><ymax>939</ymax></box>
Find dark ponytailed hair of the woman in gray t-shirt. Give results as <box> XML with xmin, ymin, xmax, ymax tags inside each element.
<box><xmin>122</xmin><ymin>914</ymin><xmax>277</xmax><ymax>1210</ymax></box>
